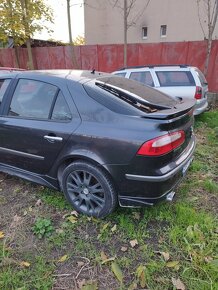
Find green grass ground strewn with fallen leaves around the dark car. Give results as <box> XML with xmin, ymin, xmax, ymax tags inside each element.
<box><xmin>0</xmin><ymin>111</ymin><xmax>218</xmax><ymax>290</ymax></box>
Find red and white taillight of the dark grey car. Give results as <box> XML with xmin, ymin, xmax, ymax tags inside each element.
<box><xmin>137</xmin><ymin>131</ymin><xmax>185</xmax><ymax>156</ymax></box>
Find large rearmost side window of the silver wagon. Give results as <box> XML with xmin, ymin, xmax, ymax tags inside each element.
<box><xmin>156</xmin><ymin>71</ymin><xmax>195</xmax><ymax>87</ymax></box>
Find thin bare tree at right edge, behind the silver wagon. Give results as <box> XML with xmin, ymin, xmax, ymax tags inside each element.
<box><xmin>197</xmin><ymin>0</ymin><xmax>218</xmax><ymax>76</ymax></box>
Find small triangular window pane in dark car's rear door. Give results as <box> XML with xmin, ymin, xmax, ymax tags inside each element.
<box><xmin>51</xmin><ymin>92</ymin><xmax>72</xmax><ymax>121</ymax></box>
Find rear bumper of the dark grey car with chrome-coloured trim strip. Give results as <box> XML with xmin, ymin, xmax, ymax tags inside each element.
<box><xmin>114</xmin><ymin>136</ymin><xmax>196</xmax><ymax>207</ymax></box>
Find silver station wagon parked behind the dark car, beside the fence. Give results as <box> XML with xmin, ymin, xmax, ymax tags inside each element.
<box><xmin>113</xmin><ymin>65</ymin><xmax>208</xmax><ymax>115</ymax></box>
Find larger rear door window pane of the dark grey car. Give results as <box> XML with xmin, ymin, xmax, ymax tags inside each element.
<box><xmin>9</xmin><ymin>79</ymin><xmax>58</xmax><ymax>119</ymax></box>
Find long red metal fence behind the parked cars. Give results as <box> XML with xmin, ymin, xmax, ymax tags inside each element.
<box><xmin>0</xmin><ymin>40</ymin><xmax>218</xmax><ymax>92</ymax></box>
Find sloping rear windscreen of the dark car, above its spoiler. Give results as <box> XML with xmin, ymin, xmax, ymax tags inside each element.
<box><xmin>84</xmin><ymin>76</ymin><xmax>177</xmax><ymax>115</ymax></box>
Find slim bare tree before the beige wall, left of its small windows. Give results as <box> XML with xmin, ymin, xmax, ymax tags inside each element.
<box><xmin>109</xmin><ymin>0</ymin><xmax>150</xmax><ymax>67</ymax></box>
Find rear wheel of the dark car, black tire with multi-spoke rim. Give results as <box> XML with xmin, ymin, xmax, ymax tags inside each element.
<box><xmin>61</xmin><ymin>161</ymin><xmax>117</xmax><ymax>218</ymax></box>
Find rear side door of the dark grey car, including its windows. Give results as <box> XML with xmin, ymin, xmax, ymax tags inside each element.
<box><xmin>0</xmin><ymin>78</ymin><xmax>81</xmax><ymax>174</ymax></box>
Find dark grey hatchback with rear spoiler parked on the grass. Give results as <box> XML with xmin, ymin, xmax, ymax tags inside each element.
<box><xmin>0</xmin><ymin>70</ymin><xmax>195</xmax><ymax>217</ymax></box>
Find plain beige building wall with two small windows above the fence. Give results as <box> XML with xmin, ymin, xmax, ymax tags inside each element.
<box><xmin>84</xmin><ymin>0</ymin><xmax>218</xmax><ymax>45</ymax></box>
